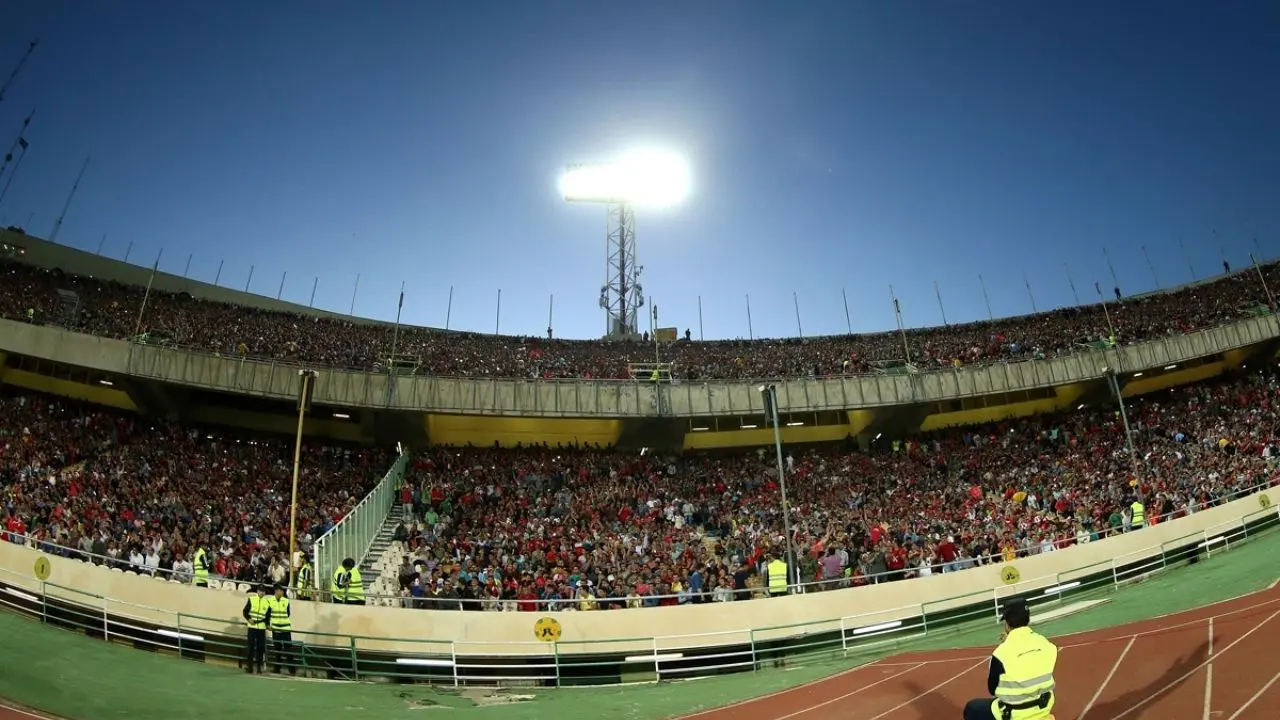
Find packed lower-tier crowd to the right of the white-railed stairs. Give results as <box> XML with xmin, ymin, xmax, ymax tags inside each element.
<box><xmin>381</xmin><ymin>363</ymin><xmax>1280</xmax><ymax>611</ymax></box>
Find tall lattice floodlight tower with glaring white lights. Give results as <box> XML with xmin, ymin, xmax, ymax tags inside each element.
<box><xmin>559</xmin><ymin>152</ymin><xmax>689</xmax><ymax>338</ymax></box>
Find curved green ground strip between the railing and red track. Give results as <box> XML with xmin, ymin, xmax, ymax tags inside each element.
<box><xmin>0</xmin><ymin>532</ymin><xmax>1280</xmax><ymax>720</ymax></box>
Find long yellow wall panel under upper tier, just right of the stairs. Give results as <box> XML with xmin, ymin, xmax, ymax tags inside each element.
<box><xmin>424</xmin><ymin>414</ymin><xmax>622</xmax><ymax>447</ymax></box>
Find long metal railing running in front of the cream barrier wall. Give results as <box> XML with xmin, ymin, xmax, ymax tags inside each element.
<box><xmin>0</xmin><ymin>499</ymin><xmax>1280</xmax><ymax>687</ymax></box>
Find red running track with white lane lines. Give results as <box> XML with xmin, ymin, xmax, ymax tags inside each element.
<box><xmin>0</xmin><ymin>588</ymin><xmax>1280</xmax><ymax>720</ymax></box>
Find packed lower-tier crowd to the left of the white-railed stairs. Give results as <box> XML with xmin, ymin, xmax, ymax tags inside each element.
<box><xmin>0</xmin><ymin>388</ymin><xmax>393</xmax><ymax>582</ymax></box>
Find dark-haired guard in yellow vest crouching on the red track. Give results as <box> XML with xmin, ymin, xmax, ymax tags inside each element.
<box><xmin>964</xmin><ymin>597</ymin><xmax>1057</xmax><ymax>720</ymax></box>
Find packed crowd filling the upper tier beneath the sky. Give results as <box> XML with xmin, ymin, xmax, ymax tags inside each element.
<box><xmin>0</xmin><ymin>260</ymin><xmax>1280</xmax><ymax>379</ymax></box>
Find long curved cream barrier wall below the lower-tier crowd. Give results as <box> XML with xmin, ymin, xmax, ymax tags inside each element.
<box><xmin>0</xmin><ymin>488</ymin><xmax>1280</xmax><ymax>655</ymax></box>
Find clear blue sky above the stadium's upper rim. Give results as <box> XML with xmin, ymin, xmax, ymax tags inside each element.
<box><xmin>0</xmin><ymin>0</ymin><xmax>1280</xmax><ymax>340</ymax></box>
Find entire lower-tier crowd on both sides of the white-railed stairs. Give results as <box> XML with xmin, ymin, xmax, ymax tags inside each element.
<box><xmin>0</xmin><ymin>369</ymin><xmax>1280</xmax><ymax>610</ymax></box>
